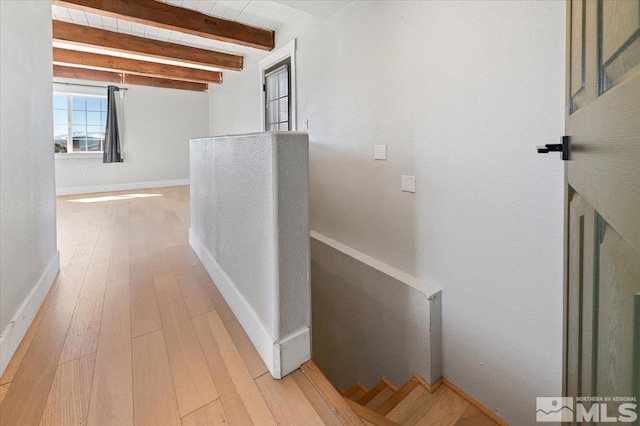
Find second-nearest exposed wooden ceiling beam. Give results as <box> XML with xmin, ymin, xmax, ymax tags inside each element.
<box><xmin>53</xmin><ymin>20</ymin><xmax>243</xmax><ymax>71</ymax></box>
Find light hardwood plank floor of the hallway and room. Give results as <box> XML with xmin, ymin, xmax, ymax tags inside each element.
<box><xmin>0</xmin><ymin>187</ymin><xmax>342</xmax><ymax>426</ymax></box>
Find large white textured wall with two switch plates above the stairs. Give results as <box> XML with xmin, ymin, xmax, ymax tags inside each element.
<box><xmin>210</xmin><ymin>1</ymin><xmax>565</xmax><ymax>425</ymax></box>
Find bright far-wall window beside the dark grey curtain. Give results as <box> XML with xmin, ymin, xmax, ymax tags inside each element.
<box><xmin>53</xmin><ymin>93</ymin><xmax>107</xmax><ymax>153</ymax></box>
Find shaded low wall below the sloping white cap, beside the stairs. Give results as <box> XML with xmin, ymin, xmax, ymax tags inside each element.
<box><xmin>311</xmin><ymin>238</ymin><xmax>442</xmax><ymax>389</ymax></box>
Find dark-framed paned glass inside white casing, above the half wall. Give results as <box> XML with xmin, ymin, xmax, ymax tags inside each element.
<box><xmin>263</xmin><ymin>58</ymin><xmax>291</xmax><ymax>130</ymax></box>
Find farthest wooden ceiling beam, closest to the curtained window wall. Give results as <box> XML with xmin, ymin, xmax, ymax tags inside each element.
<box><xmin>53</xmin><ymin>65</ymin><xmax>209</xmax><ymax>92</ymax></box>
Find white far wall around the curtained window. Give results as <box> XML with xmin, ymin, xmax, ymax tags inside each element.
<box><xmin>54</xmin><ymin>78</ymin><xmax>209</xmax><ymax>194</ymax></box>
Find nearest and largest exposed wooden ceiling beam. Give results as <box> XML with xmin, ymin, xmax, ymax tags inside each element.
<box><xmin>53</xmin><ymin>0</ymin><xmax>275</xmax><ymax>50</ymax></box>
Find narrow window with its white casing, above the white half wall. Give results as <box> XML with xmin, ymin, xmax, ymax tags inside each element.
<box><xmin>258</xmin><ymin>39</ymin><xmax>296</xmax><ymax>131</ymax></box>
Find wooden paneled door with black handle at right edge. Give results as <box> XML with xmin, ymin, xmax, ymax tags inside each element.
<box><xmin>564</xmin><ymin>0</ymin><xmax>640</xmax><ymax>424</ymax></box>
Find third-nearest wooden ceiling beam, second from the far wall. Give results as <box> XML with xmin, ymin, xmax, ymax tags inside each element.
<box><xmin>53</xmin><ymin>48</ymin><xmax>222</xmax><ymax>84</ymax></box>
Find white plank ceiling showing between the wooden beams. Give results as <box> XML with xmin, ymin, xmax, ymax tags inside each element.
<box><xmin>52</xmin><ymin>0</ymin><xmax>300</xmax><ymax>70</ymax></box>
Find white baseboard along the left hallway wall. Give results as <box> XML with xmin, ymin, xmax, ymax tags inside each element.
<box><xmin>0</xmin><ymin>251</ymin><xmax>60</xmax><ymax>376</ymax></box>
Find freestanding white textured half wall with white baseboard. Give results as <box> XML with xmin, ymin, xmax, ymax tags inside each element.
<box><xmin>189</xmin><ymin>132</ymin><xmax>311</xmax><ymax>378</ymax></box>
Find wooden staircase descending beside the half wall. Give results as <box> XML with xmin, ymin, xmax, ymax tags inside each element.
<box><xmin>301</xmin><ymin>361</ymin><xmax>506</xmax><ymax>426</ymax></box>
